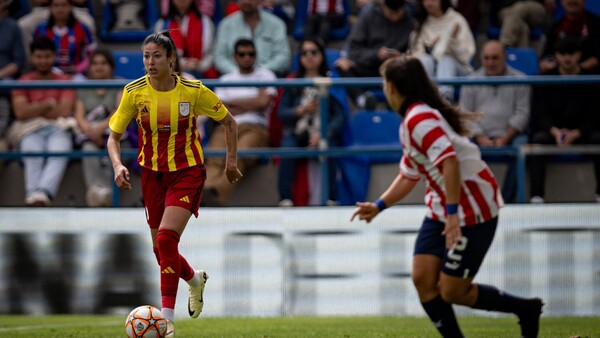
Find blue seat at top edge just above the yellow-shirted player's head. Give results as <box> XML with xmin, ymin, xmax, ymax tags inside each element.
<box><xmin>99</xmin><ymin>1</ymin><xmax>158</xmax><ymax>43</ymax></box>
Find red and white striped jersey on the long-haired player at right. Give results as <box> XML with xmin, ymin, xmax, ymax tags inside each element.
<box><xmin>400</xmin><ymin>103</ymin><xmax>504</xmax><ymax>226</ymax></box>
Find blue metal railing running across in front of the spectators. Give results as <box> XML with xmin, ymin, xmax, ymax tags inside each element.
<box><xmin>0</xmin><ymin>75</ymin><xmax>600</xmax><ymax>205</ymax></box>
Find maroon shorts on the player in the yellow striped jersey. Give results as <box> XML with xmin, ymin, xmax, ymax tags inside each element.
<box><xmin>142</xmin><ymin>165</ymin><xmax>206</xmax><ymax>229</ymax></box>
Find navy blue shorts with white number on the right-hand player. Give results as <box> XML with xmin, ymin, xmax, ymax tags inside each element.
<box><xmin>414</xmin><ymin>217</ymin><xmax>498</xmax><ymax>278</ymax></box>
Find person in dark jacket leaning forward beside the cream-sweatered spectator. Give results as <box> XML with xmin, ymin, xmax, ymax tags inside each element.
<box><xmin>335</xmin><ymin>0</ymin><xmax>414</xmax><ymax>108</ymax></box>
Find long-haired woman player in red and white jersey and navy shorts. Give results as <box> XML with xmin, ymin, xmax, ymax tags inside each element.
<box><xmin>351</xmin><ymin>56</ymin><xmax>543</xmax><ymax>337</ymax></box>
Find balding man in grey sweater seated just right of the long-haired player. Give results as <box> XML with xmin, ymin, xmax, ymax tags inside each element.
<box><xmin>460</xmin><ymin>40</ymin><xmax>531</xmax><ymax>201</ymax></box>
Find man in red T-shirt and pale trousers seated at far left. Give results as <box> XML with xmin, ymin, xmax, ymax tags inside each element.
<box><xmin>9</xmin><ymin>37</ymin><xmax>75</xmax><ymax>206</ymax></box>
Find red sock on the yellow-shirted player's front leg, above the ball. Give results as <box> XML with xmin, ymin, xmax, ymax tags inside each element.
<box><xmin>156</xmin><ymin>229</ymin><xmax>180</xmax><ymax>309</ymax></box>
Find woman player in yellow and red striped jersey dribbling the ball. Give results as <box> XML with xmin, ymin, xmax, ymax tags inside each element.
<box><xmin>107</xmin><ymin>32</ymin><xmax>242</xmax><ymax>337</ymax></box>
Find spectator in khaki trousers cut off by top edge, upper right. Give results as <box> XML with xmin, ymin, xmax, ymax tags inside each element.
<box><xmin>490</xmin><ymin>0</ymin><xmax>556</xmax><ymax>48</ymax></box>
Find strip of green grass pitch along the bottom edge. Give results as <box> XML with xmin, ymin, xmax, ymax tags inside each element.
<box><xmin>0</xmin><ymin>315</ymin><xmax>600</xmax><ymax>338</ymax></box>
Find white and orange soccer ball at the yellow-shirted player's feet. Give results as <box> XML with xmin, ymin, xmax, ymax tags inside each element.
<box><xmin>125</xmin><ymin>305</ymin><xmax>167</xmax><ymax>338</ymax></box>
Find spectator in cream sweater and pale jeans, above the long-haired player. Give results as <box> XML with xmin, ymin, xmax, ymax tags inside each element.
<box><xmin>410</xmin><ymin>0</ymin><xmax>475</xmax><ymax>101</ymax></box>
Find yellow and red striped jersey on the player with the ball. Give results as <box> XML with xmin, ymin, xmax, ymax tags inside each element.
<box><xmin>109</xmin><ymin>75</ymin><xmax>227</xmax><ymax>171</ymax></box>
